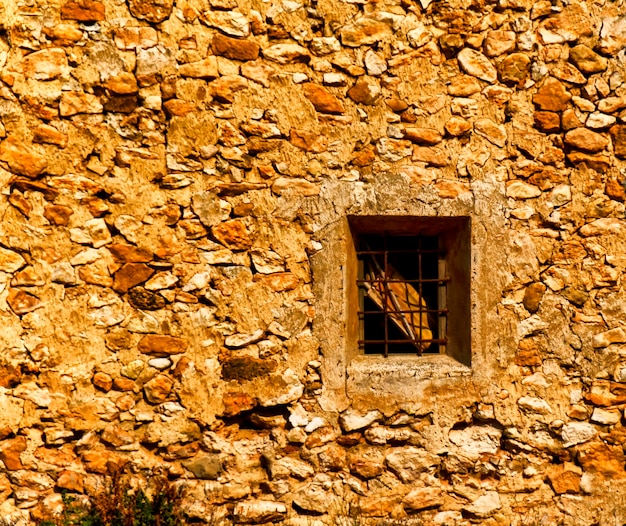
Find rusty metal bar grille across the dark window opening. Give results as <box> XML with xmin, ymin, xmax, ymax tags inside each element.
<box><xmin>357</xmin><ymin>233</ymin><xmax>449</xmax><ymax>356</ymax></box>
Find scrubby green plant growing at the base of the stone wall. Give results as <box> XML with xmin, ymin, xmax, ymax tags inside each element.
<box><xmin>38</xmin><ymin>471</ymin><xmax>185</xmax><ymax>526</ymax></box>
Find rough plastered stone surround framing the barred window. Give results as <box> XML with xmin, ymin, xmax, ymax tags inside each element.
<box><xmin>311</xmin><ymin>178</ymin><xmax>504</xmax><ymax>412</ymax></box>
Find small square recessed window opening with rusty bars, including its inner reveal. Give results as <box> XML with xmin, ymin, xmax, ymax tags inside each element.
<box><xmin>349</xmin><ymin>216</ymin><xmax>471</xmax><ymax>365</ymax></box>
